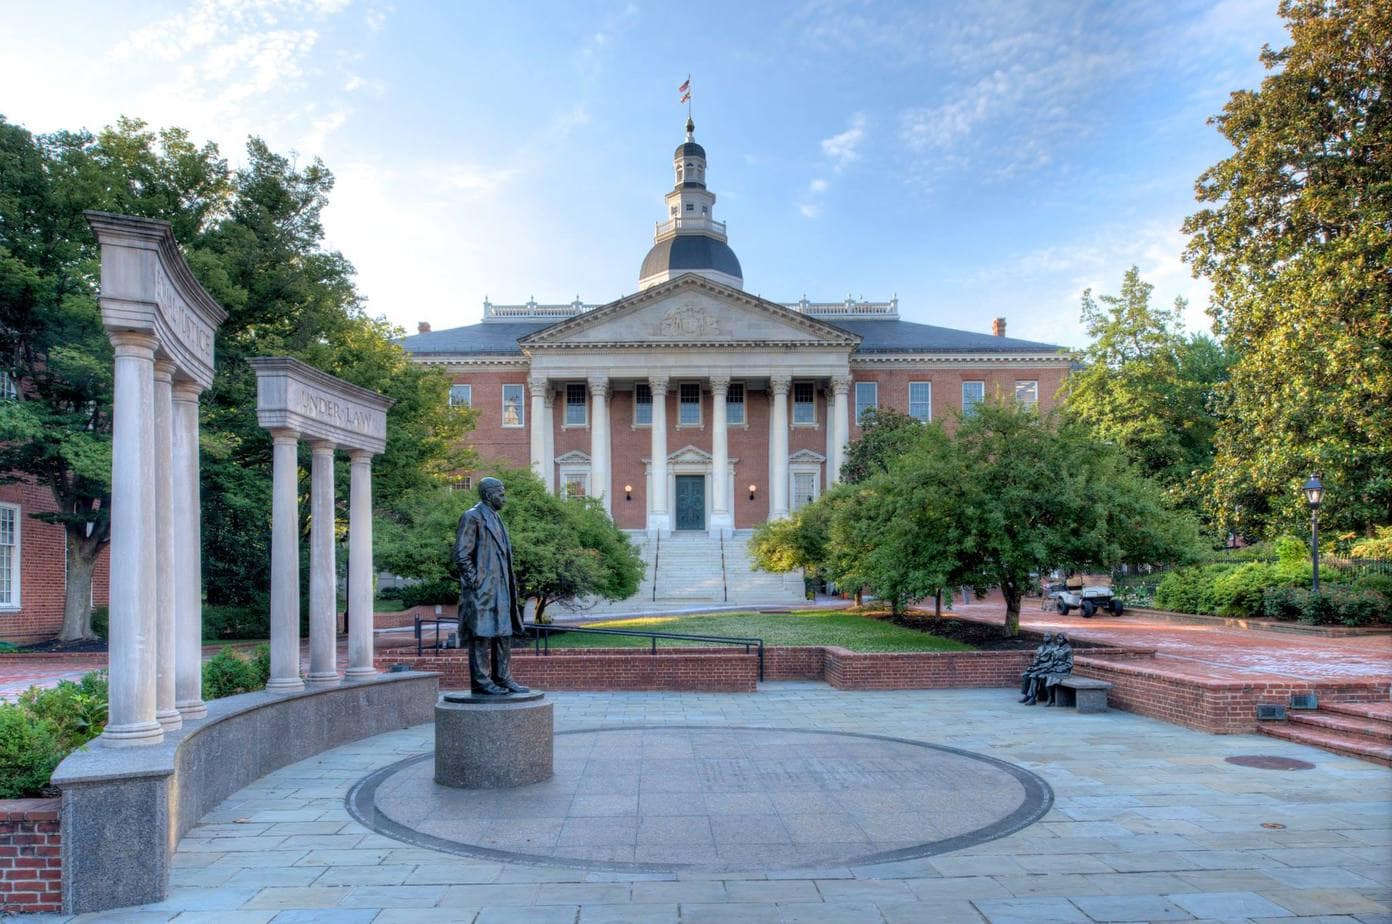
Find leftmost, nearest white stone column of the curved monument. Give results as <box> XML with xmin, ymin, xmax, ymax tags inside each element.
<box><xmin>102</xmin><ymin>331</ymin><xmax>164</xmax><ymax>746</ymax></box>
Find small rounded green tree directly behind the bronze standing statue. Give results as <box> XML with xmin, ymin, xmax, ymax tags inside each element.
<box><xmin>376</xmin><ymin>469</ymin><xmax>643</xmax><ymax>623</ymax></box>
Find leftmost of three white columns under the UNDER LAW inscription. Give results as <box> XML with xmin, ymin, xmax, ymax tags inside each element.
<box><xmin>266</xmin><ymin>430</ymin><xmax>305</xmax><ymax>690</ymax></box>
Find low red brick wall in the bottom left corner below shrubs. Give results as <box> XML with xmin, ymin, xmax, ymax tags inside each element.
<box><xmin>0</xmin><ymin>799</ymin><xmax>63</xmax><ymax>914</ymax></box>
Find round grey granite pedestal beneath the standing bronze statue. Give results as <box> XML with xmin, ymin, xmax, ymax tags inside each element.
<box><xmin>434</xmin><ymin>690</ymin><xmax>554</xmax><ymax>789</ymax></box>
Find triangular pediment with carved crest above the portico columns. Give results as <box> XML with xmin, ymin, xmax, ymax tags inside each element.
<box><xmin>518</xmin><ymin>274</ymin><xmax>860</xmax><ymax>349</ymax></box>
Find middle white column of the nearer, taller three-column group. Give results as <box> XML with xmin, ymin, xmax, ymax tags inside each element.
<box><xmin>155</xmin><ymin>359</ymin><xmax>184</xmax><ymax>732</ymax></box>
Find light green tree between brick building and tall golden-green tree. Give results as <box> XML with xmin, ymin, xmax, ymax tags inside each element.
<box><xmin>1065</xmin><ymin>266</ymin><xmax>1228</xmax><ymax>512</ymax></box>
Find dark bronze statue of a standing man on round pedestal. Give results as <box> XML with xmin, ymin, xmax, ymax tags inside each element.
<box><xmin>454</xmin><ymin>479</ymin><xmax>529</xmax><ymax>696</ymax></box>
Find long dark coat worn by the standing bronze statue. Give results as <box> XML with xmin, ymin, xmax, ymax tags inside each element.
<box><xmin>454</xmin><ymin>501</ymin><xmax>522</xmax><ymax>637</ymax></box>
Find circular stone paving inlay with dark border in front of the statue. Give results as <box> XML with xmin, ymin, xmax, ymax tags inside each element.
<box><xmin>348</xmin><ymin>725</ymin><xmax>1054</xmax><ymax>873</ymax></box>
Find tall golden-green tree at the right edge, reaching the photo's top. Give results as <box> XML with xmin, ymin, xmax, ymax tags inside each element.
<box><xmin>1185</xmin><ymin>0</ymin><xmax>1392</xmax><ymax>534</ymax></box>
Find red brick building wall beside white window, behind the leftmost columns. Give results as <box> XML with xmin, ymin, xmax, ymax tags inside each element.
<box><xmin>0</xmin><ymin>483</ymin><xmax>110</xmax><ymax>644</ymax></box>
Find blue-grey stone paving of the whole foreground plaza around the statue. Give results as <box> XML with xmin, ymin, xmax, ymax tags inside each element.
<box><xmin>26</xmin><ymin>683</ymin><xmax>1392</xmax><ymax>924</ymax></box>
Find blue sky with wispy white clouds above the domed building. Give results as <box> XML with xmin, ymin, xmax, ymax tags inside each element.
<box><xmin>0</xmin><ymin>0</ymin><xmax>1286</xmax><ymax>347</ymax></box>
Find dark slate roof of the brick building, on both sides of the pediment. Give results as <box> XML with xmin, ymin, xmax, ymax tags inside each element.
<box><xmin>400</xmin><ymin>319</ymin><xmax>1062</xmax><ymax>356</ymax></box>
